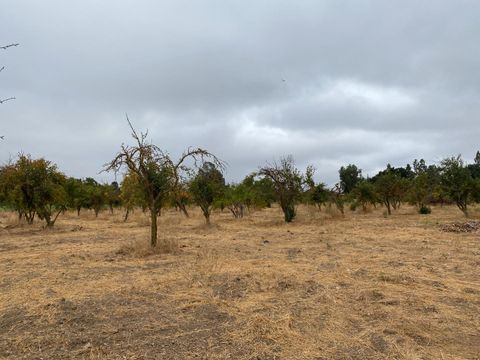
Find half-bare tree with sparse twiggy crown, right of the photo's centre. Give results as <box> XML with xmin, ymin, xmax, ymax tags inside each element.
<box><xmin>258</xmin><ymin>156</ymin><xmax>305</xmax><ymax>223</ymax></box>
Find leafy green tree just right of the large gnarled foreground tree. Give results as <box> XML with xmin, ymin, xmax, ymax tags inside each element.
<box><xmin>189</xmin><ymin>162</ymin><xmax>225</xmax><ymax>225</ymax></box>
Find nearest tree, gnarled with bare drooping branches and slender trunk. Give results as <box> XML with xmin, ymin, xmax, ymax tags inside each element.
<box><xmin>104</xmin><ymin>115</ymin><xmax>224</xmax><ymax>247</ymax></box>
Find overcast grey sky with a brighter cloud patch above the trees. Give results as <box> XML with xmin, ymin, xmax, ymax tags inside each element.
<box><xmin>0</xmin><ymin>0</ymin><xmax>480</xmax><ymax>184</ymax></box>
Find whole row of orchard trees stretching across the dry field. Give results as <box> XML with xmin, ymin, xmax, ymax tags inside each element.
<box><xmin>0</xmin><ymin>122</ymin><xmax>480</xmax><ymax>247</ymax></box>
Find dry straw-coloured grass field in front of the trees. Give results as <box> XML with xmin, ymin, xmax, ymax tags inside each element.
<box><xmin>0</xmin><ymin>207</ymin><xmax>480</xmax><ymax>360</ymax></box>
